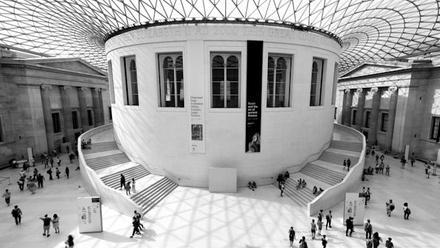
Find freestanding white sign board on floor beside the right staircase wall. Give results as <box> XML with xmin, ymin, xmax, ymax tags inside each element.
<box><xmin>343</xmin><ymin>193</ymin><xmax>365</xmax><ymax>225</ymax></box>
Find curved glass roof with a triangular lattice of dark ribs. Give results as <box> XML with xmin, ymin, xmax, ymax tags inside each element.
<box><xmin>0</xmin><ymin>0</ymin><xmax>440</xmax><ymax>72</ymax></box>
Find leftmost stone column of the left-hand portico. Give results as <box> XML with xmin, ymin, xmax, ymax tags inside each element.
<box><xmin>40</xmin><ymin>84</ymin><xmax>55</xmax><ymax>154</ymax></box>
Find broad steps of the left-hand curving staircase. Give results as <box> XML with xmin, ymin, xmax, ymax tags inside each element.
<box><xmin>82</xmin><ymin>141</ymin><xmax>178</xmax><ymax>215</ymax></box>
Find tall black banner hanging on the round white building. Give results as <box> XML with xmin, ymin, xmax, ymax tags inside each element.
<box><xmin>246</xmin><ymin>40</ymin><xmax>263</xmax><ymax>152</ymax></box>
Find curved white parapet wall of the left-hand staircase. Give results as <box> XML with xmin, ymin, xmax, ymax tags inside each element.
<box><xmin>78</xmin><ymin>124</ymin><xmax>142</xmax><ymax>214</ymax></box>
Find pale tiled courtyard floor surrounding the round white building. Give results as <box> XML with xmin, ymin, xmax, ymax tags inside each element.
<box><xmin>0</xmin><ymin>131</ymin><xmax>440</xmax><ymax>248</ymax></box>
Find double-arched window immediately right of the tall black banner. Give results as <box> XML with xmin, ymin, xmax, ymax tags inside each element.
<box><xmin>267</xmin><ymin>54</ymin><xmax>292</xmax><ymax>108</ymax></box>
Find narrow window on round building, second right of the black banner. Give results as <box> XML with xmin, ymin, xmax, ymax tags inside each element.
<box><xmin>310</xmin><ymin>58</ymin><xmax>324</xmax><ymax>106</ymax></box>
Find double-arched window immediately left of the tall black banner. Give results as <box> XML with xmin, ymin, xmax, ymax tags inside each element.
<box><xmin>211</xmin><ymin>53</ymin><xmax>240</xmax><ymax>108</ymax></box>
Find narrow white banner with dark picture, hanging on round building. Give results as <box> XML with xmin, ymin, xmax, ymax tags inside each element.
<box><xmin>190</xmin><ymin>96</ymin><xmax>205</xmax><ymax>153</ymax></box>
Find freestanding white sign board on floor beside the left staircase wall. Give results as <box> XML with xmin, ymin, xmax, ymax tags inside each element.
<box><xmin>77</xmin><ymin>196</ymin><xmax>102</xmax><ymax>233</ymax></box>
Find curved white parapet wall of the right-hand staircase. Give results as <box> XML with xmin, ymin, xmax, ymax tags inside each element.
<box><xmin>307</xmin><ymin>124</ymin><xmax>366</xmax><ymax>216</ymax></box>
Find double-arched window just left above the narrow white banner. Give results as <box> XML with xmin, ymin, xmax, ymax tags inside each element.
<box><xmin>158</xmin><ymin>53</ymin><xmax>185</xmax><ymax>108</ymax></box>
